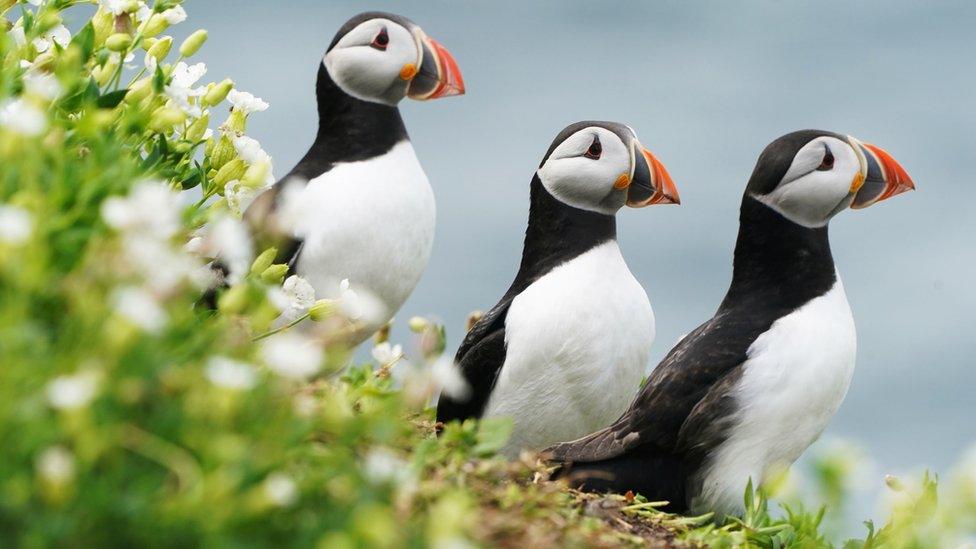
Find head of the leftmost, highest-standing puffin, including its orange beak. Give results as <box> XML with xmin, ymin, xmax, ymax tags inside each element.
<box><xmin>322</xmin><ymin>12</ymin><xmax>464</xmax><ymax>105</ymax></box>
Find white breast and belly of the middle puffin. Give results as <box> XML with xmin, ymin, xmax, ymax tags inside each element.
<box><xmin>485</xmin><ymin>241</ymin><xmax>654</xmax><ymax>456</ymax></box>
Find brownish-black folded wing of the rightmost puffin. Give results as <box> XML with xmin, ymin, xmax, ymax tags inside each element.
<box><xmin>546</xmin><ymin>304</ymin><xmax>768</xmax><ymax>463</ymax></box>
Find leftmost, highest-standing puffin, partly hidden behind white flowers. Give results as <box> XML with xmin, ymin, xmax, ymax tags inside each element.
<box><xmin>244</xmin><ymin>12</ymin><xmax>465</xmax><ymax>346</ymax></box>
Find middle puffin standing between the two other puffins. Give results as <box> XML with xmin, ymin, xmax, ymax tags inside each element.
<box><xmin>437</xmin><ymin>121</ymin><xmax>680</xmax><ymax>458</ymax></box>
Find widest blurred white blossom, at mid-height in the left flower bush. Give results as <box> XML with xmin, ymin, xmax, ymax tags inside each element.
<box><xmin>102</xmin><ymin>181</ymin><xmax>182</xmax><ymax>239</ymax></box>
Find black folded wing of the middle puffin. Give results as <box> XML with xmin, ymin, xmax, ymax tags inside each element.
<box><xmin>437</xmin><ymin>296</ymin><xmax>514</xmax><ymax>423</ymax></box>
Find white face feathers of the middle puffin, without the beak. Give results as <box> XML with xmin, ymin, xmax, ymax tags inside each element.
<box><xmin>538</xmin><ymin>126</ymin><xmax>632</xmax><ymax>215</ymax></box>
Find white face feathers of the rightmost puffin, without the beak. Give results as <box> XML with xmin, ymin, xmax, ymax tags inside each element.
<box><xmin>755</xmin><ymin>136</ymin><xmax>861</xmax><ymax>228</ymax></box>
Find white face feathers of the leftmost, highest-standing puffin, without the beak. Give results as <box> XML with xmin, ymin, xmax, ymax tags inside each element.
<box><xmin>323</xmin><ymin>18</ymin><xmax>420</xmax><ymax>105</ymax></box>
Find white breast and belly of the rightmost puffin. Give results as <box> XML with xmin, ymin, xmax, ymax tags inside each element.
<box><xmin>696</xmin><ymin>276</ymin><xmax>857</xmax><ymax>513</ymax></box>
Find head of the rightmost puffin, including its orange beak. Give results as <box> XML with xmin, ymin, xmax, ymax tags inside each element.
<box><xmin>746</xmin><ymin>130</ymin><xmax>915</xmax><ymax>228</ymax></box>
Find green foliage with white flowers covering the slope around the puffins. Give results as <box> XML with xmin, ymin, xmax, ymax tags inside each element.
<box><xmin>0</xmin><ymin>0</ymin><xmax>976</xmax><ymax>548</ymax></box>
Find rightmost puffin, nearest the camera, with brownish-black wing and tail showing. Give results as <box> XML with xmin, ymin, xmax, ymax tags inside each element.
<box><xmin>544</xmin><ymin>130</ymin><xmax>915</xmax><ymax>516</ymax></box>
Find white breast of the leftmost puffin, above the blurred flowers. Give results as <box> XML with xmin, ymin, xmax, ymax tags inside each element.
<box><xmin>296</xmin><ymin>141</ymin><xmax>435</xmax><ymax>343</ymax></box>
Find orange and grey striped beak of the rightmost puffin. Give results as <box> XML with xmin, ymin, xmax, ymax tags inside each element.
<box><xmin>849</xmin><ymin>137</ymin><xmax>915</xmax><ymax>210</ymax></box>
